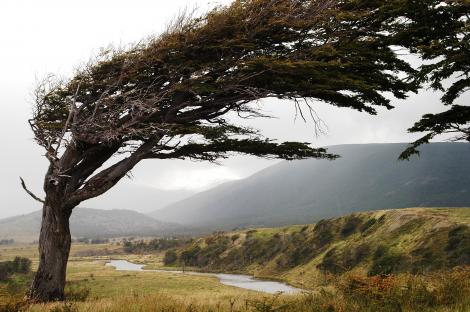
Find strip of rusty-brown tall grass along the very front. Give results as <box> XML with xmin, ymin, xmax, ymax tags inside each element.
<box><xmin>0</xmin><ymin>267</ymin><xmax>470</xmax><ymax>312</ymax></box>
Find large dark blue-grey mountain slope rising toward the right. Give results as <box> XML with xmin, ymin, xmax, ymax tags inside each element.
<box><xmin>150</xmin><ymin>143</ymin><xmax>470</xmax><ymax>229</ymax></box>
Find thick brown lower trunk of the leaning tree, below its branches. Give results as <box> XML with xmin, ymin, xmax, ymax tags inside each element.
<box><xmin>28</xmin><ymin>194</ymin><xmax>71</xmax><ymax>302</ymax></box>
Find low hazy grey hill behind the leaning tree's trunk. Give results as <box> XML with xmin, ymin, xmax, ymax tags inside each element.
<box><xmin>0</xmin><ymin>208</ymin><xmax>184</xmax><ymax>242</ymax></box>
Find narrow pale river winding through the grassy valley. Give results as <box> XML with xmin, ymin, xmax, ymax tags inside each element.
<box><xmin>106</xmin><ymin>260</ymin><xmax>301</xmax><ymax>294</ymax></box>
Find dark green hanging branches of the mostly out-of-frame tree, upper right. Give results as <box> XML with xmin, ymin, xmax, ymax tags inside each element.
<box><xmin>399</xmin><ymin>0</ymin><xmax>470</xmax><ymax>159</ymax></box>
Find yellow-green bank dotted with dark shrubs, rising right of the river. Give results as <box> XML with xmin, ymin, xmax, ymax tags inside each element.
<box><xmin>164</xmin><ymin>208</ymin><xmax>470</xmax><ymax>288</ymax></box>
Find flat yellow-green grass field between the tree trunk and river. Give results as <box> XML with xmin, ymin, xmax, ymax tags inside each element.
<box><xmin>0</xmin><ymin>244</ymin><xmax>280</xmax><ymax>311</ymax></box>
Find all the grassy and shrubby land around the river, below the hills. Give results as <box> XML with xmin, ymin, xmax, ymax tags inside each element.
<box><xmin>0</xmin><ymin>209</ymin><xmax>470</xmax><ymax>312</ymax></box>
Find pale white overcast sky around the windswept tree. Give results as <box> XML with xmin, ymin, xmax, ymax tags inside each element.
<box><xmin>0</xmin><ymin>0</ymin><xmax>469</xmax><ymax>218</ymax></box>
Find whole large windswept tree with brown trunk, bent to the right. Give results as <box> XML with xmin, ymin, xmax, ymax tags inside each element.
<box><xmin>22</xmin><ymin>0</ymin><xmax>416</xmax><ymax>301</ymax></box>
